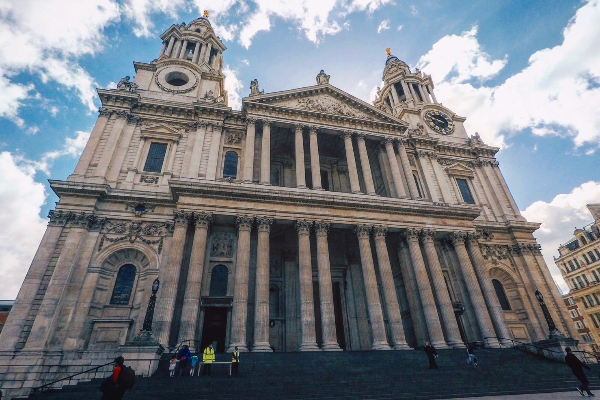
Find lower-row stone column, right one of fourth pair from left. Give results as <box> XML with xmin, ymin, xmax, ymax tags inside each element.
<box><xmin>374</xmin><ymin>226</ymin><xmax>410</xmax><ymax>350</ymax></box>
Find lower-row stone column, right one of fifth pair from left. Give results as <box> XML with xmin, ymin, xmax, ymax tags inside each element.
<box><xmin>422</xmin><ymin>229</ymin><xmax>463</xmax><ymax>347</ymax></box>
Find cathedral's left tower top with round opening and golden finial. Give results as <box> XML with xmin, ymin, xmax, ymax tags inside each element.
<box><xmin>134</xmin><ymin>11</ymin><xmax>227</xmax><ymax>105</ymax></box>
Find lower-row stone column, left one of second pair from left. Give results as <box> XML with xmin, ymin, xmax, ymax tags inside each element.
<box><xmin>227</xmin><ymin>215</ymin><xmax>254</xmax><ymax>353</ymax></box>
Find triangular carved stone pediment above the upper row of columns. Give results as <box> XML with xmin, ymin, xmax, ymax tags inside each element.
<box><xmin>244</xmin><ymin>85</ymin><xmax>406</xmax><ymax>125</ymax></box>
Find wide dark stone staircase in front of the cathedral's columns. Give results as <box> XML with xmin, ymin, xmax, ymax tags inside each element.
<box><xmin>30</xmin><ymin>349</ymin><xmax>598</xmax><ymax>400</ymax></box>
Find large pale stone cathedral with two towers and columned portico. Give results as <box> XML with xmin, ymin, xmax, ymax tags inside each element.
<box><xmin>0</xmin><ymin>12</ymin><xmax>574</xmax><ymax>396</ymax></box>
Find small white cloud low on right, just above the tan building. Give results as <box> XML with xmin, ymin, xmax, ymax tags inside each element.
<box><xmin>521</xmin><ymin>181</ymin><xmax>600</xmax><ymax>293</ymax></box>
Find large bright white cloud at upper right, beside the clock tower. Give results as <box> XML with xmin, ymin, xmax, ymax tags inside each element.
<box><xmin>417</xmin><ymin>0</ymin><xmax>600</xmax><ymax>148</ymax></box>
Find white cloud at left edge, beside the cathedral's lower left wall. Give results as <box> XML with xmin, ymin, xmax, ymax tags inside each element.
<box><xmin>0</xmin><ymin>152</ymin><xmax>47</xmax><ymax>299</ymax></box>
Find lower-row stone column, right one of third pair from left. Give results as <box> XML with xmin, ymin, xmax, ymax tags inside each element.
<box><xmin>315</xmin><ymin>221</ymin><xmax>341</xmax><ymax>351</ymax></box>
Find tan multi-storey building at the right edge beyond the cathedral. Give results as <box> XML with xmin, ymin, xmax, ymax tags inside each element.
<box><xmin>554</xmin><ymin>204</ymin><xmax>600</xmax><ymax>350</ymax></box>
